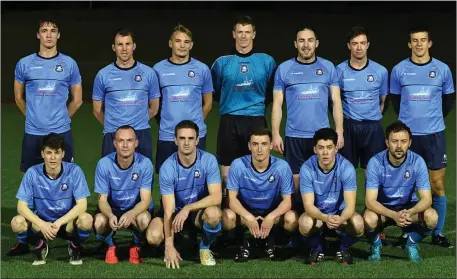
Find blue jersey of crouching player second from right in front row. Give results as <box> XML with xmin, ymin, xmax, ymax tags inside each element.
<box><xmin>300</xmin><ymin>153</ymin><xmax>357</xmax><ymax>215</ymax></box>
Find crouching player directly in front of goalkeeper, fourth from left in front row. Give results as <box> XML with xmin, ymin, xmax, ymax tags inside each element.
<box><xmin>222</xmin><ymin>129</ymin><xmax>298</xmax><ymax>262</ymax></box>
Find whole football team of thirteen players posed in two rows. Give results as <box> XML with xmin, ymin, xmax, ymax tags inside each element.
<box><xmin>8</xmin><ymin>16</ymin><xmax>455</xmax><ymax>269</ymax></box>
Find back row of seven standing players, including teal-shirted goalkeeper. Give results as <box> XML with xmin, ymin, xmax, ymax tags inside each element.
<box><xmin>10</xmin><ymin>14</ymin><xmax>454</xmax><ymax>260</ymax></box>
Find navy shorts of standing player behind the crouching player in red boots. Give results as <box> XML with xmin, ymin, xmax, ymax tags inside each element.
<box><xmin>102</xmin><ymin>129</ymin><xmax>153</xmax><ymax>162</ymax></box>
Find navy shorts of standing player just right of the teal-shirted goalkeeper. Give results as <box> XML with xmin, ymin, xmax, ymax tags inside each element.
<box><xmin>284</xmin><ymin>136</ymin><xmax>314</xmax><ymax>174</ymax></box>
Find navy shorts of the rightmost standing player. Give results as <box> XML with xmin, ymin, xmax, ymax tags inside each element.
<box><xmin>410</xmin><ymin>131</ymin><xmax>447</xmax><ymax>170</ymax></box>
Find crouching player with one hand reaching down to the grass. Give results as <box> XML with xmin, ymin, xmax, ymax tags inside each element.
<box><xmin>146</xmin><ymin>120</ymin><xmax>222</xmax><ymax>269</ymax></box>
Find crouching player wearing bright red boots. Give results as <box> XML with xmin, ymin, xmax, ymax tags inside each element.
<box><xmin>94</xmin><ymin>125</ymin><xmax>153</xmax><ymax>264</ymax></box>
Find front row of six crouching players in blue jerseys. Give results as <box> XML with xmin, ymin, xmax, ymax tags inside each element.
<box><xmin>11</xmin><ymin>120</ymin><xmax>438</xmax><ymax>269</ymax></box>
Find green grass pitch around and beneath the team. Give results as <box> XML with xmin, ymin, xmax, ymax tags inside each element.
<box><xmin>1</xmin><ymin>103</ymin><xmax>456</xmax><ymax>278</ymax></box>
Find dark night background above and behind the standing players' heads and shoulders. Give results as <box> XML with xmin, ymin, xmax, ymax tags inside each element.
<box><xmin>1</xmin><ymin>1</ymin><xmax>456</xmax><ymax>101</ymax></box>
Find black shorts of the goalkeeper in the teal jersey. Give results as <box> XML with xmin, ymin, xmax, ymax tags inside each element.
<box><xmin>217</xmin><ymin>114</ymin><xmax>267</xmax><ymax>166</ymax></box>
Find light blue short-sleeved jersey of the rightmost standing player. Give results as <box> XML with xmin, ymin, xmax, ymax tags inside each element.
<box><xmin>390</xmin><ymin>58</ymin><xmax>455</xmax><ymax>135</ymax></box>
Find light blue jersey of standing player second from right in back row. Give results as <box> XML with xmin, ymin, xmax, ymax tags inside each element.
<box><xmin>336</xmin><ymin>59</ymin><xmax>389</xmax><ymax>121</ymax></box>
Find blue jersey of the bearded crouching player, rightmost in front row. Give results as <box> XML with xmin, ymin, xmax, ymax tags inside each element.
<box><xmin>365</xmin><ymin>150</ymin><xmax>431</xmax><ymax>207</ymax></box>
